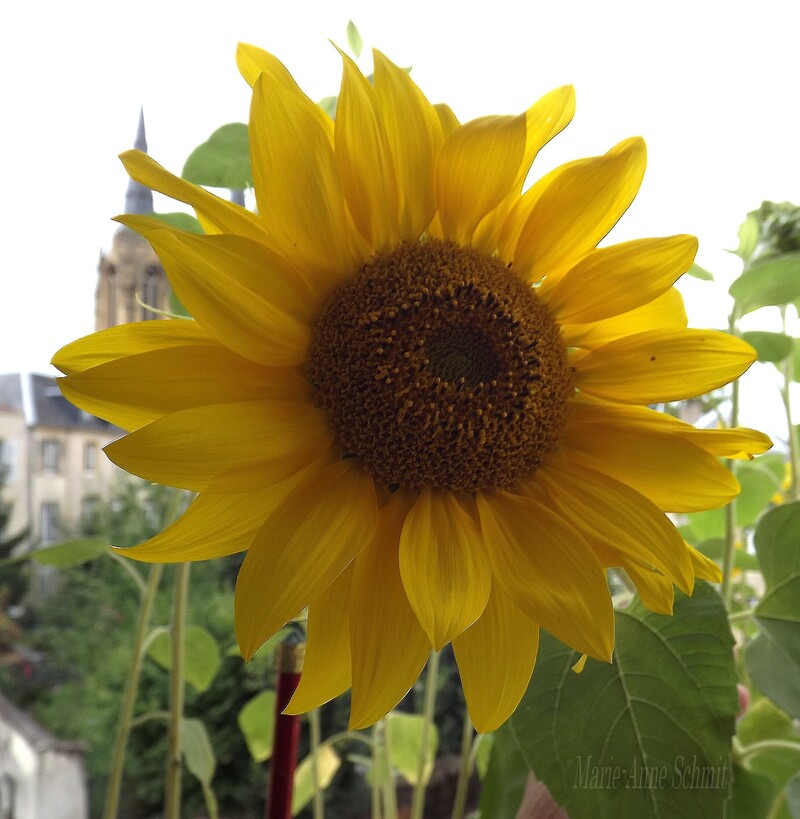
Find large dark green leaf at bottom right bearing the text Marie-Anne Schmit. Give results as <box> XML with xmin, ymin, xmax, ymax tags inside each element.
<box><xmin>511</xmin><ymin>582</ymin><xmax>738</xmax><ymax>819</ymax></box>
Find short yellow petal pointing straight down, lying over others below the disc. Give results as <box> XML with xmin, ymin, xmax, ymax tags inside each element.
<box><xmin>400</xmin><ymin>489</ymin><xmax>490</xmax><ymax>651</ymax></box>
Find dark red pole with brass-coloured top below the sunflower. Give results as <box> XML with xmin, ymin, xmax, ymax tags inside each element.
<box><xmin>264</xmin><ymin>640</ymin><xmax>306</xmax><ymax>819</ymax></box>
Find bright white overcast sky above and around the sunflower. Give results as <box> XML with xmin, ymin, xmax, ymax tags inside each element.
<box><xmin>0</xmin><ymin>0</ymin><xmax>800</xmax><ymax>436</ymax></box>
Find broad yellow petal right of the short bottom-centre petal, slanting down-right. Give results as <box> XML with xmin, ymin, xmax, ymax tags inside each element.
<box><xmin>477</xmin><ymin>491</ymin><xmax>614</xmax><ymax>660</ymax></box>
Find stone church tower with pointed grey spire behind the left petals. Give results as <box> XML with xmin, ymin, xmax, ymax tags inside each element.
<box><xmin>95</xmin><ymin>112</ymin><xmax>170</xmax><ymax>330</ymax></box>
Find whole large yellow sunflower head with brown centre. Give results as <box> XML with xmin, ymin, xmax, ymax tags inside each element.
<box><xmin>54</xmin><ymin>45</ymin><xmax>770</xmax><ymax>731</ymax></box>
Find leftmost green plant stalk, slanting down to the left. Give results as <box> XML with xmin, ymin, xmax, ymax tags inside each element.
<box><xmin>103</xmin><ymin>563</ymin><xmax>164</xmax><ymax>819</ymax></box>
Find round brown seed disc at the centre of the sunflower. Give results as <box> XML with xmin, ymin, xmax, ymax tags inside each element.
<box><xmin>309</xmin><ymin>239</ymin><xmax>573</xmax><ymax>492</ymax></box>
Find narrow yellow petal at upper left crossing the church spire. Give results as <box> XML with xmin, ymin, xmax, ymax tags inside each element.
<box><xmin>120</xmin><ymin>151</ymin><xmax>269</xmax><ymax>242</ymax></box>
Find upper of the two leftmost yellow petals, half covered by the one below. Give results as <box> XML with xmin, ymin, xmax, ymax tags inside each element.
<box><xmin>52</xmin><ymin>319</ymin><xmax>215</xmax><ymax>375</ymax></box>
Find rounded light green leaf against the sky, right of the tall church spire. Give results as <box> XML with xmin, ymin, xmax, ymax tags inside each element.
<box><xmin>181</xmin><ymin>122</ymin><xmax>253</xmax><ymax>190</ymax></box>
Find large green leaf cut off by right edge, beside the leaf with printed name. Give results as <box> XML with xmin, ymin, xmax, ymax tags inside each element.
<box><xmin>745</xmin><ymin>503</ymin><xmax>800</xmax><ymax>717</ymax></box>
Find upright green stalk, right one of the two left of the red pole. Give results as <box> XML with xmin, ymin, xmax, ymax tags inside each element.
<box><xmin>164</xmin><ymin>563</ymin><xmax>191</xmax><ymax>819</ymax></box>
